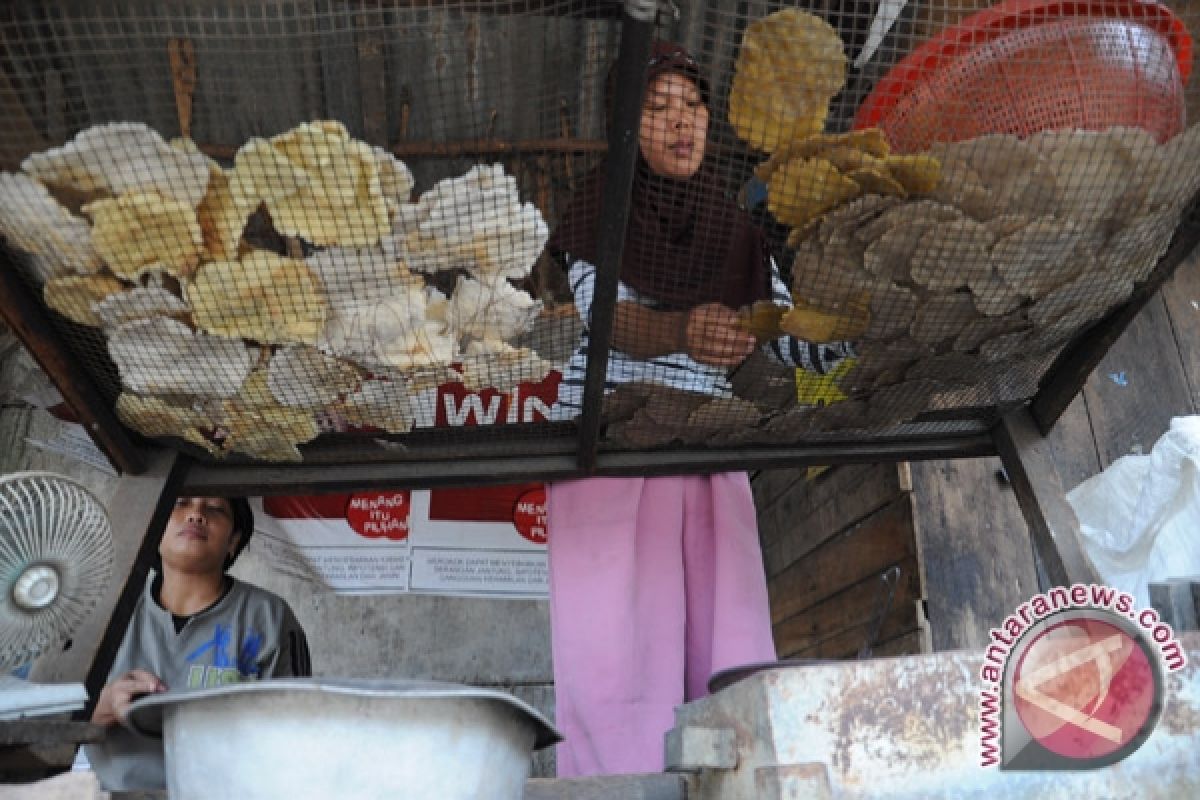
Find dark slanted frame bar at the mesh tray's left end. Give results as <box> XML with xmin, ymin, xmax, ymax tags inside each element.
<box><xmin>0</xmin><ymin>253</ymin><xmax>145</xmax><ymax>475</ymax></box>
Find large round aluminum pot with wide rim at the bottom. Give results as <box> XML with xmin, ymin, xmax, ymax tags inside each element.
<box><xmin>126</xmin><ymin>679</ymin><xmax>562</xmax><ymax>800</ymax></box>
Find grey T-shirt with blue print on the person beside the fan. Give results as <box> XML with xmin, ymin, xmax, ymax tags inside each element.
<box><xmin>86</xmin><ymin>578</ymin><xmax>312</xmax><ymax>792</ymax></box>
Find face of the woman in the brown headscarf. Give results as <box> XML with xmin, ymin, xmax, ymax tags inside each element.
<box><xmin>637</xmin><ymin>72</ymin><xmax>708</xmax><ymax>180</ymax></box>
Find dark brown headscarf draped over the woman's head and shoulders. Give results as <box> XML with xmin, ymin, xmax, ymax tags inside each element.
<box><xmin>550</xmin><ymin>42</ymin><xmax>770</xmax><ymax>311</ymax></box>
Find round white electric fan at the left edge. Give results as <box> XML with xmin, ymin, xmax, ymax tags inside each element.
<box><xmin>0</xmin><ymin>473</ymin><xmax>113</xmax><ymax>674</ymax></box>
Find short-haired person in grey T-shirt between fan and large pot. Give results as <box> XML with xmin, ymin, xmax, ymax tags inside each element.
<box><xmin>86</xmin><ymin>498</ymin><xmax>312</xmax><ymax>790</ymax></box>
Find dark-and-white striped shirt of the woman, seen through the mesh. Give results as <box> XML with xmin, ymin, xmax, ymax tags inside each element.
<box><xmin>551</xmin><ymin>260</ymin><xmax>854</xmax><ymax>420</ymax></box>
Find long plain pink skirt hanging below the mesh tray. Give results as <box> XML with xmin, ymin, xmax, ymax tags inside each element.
<box><xmin>547</xmin><ymin>473</ymin><xmax>775</xmax><ymax>777</ymax></box>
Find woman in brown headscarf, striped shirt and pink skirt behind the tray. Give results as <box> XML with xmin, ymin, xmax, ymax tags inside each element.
<box><xmin>547</xmin><ymin>42</ymin><xmax>851</xmax><ymax>777</ymax></box>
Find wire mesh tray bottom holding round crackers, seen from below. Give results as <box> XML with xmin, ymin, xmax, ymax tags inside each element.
<box><xmin>0</xmin><ymin>0</ymin><xmax>1200</xmax><ymax>467</ymax></box>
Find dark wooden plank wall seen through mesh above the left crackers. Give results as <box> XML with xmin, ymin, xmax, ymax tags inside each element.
<box><xmin>0</xmin><ymin>0</ymin><xmax>618</xmax><ymax>218</ymax></box>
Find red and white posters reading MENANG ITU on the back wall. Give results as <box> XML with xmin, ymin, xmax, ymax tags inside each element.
<box><xmin>254</xmin><ymin>483</ymin><xmax>548</xmax><ymax>597</ymax></box>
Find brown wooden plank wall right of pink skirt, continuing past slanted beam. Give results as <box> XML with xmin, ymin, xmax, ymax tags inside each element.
<box><xmin>752</xmin><ymin>248</ymin><xmax>1200</xmax><ymax>657</ymax></box>
